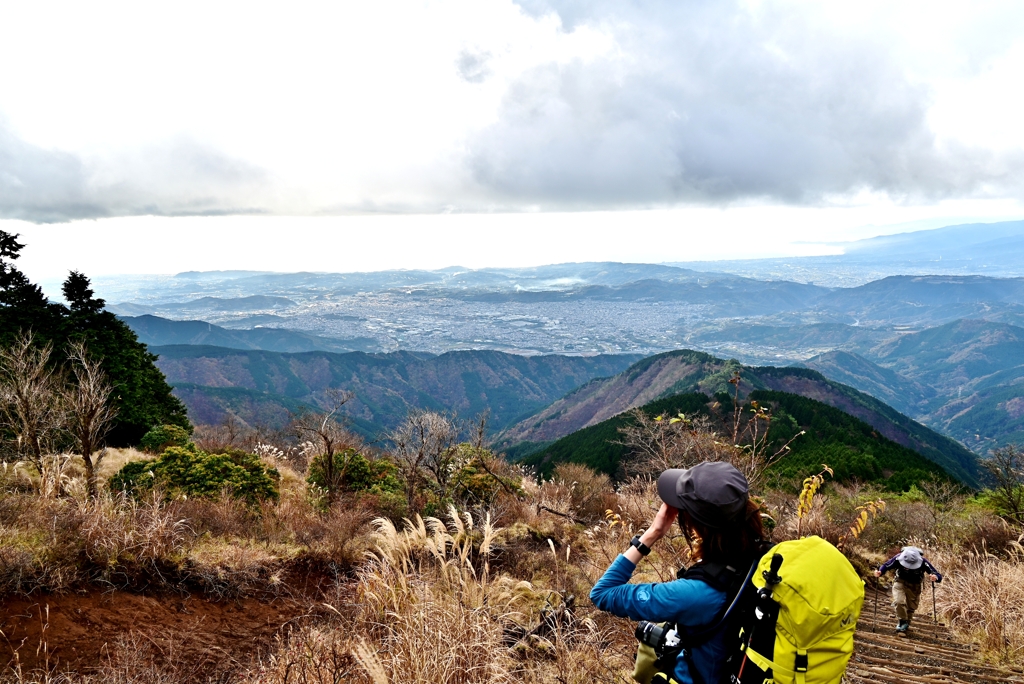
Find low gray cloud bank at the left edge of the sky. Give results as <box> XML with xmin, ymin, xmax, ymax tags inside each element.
<box><xmin>0</xmin><ymin>120</ymin><xmax>268</xmax><ymax>223</ymax></box>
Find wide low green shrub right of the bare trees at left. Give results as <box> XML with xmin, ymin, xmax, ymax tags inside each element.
<box><xmin>110</xmin><ymin>443</ymin><xmax>280</xmax><ymax>503</ymax></box>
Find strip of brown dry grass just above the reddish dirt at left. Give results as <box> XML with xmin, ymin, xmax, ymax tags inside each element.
<box><xmin>0</xmin><ymin>481</ymin><xmax>373</xmax><ymax>598</ymax></box>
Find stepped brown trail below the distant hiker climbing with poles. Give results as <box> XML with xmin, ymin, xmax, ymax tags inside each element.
<box><xmin>845</xmin><ymin>588</ymin><xmax>1024</xmax><ymax>684</ymax></box>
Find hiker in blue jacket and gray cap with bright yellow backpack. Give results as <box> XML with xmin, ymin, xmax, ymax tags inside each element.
<box><xmin>590</xmin><ymin>463</ymin><xmax>864</xmax><ymax>684</ymax></box>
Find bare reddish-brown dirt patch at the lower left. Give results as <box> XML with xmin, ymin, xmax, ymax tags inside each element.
<box><xmin>0</xmin><ymin>591</ymin><xmax>307</xmax><ymax>673</ymax></box>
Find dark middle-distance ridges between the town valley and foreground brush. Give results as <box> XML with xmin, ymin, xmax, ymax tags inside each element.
<box><xmin>154</xmin><ymin>345</ymin><xmax>979</xmax><ymax>485</ymax></box>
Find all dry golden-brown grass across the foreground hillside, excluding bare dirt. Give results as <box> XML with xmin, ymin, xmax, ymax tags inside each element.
<box><xmin>6</xmin><ymin>446</ymin><xmax>1024</xmax><ymax>684</ymax></box>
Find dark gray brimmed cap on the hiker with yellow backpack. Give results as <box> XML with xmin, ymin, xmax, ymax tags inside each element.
<box><xmin>657</xmin><ymin>462</ymin><xmax>749</xmax><ymax>529</ymax></box>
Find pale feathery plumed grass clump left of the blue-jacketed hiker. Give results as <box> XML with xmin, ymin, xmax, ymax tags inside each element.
<box><xmin>237</xmin><ymin>510</ymin><xmax>632</xmax><ymax>684</ymax></box>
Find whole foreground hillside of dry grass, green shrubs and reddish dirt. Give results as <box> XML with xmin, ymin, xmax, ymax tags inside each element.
<box><xmin>0</xmin><ymin>401</ymin><xmax>1024</xmax><ymax>684</ymax></box>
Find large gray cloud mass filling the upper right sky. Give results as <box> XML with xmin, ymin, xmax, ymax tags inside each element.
<box><xmin>468</xmin><ymin>0</ymin><xmax>1024</xmax><ymax>208</ymax></box>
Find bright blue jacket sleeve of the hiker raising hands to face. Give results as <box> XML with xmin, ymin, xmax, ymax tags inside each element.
<box><xmin>590</xmin><ymin>556</ymin><xmax>726</xmax><ymax>627</ymax></box>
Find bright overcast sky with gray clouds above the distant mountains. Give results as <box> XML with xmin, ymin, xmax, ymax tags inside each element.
<box><xmin>0</xmin><ymin>0</ymin><xmax>1024</xmax><ymax>277</ymax></box>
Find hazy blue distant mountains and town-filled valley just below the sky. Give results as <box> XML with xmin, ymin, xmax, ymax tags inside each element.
<box><xmin>96</xmin><ymin>221</ymin><xmax>1024</xmax><ymax>453</ymax></box>
